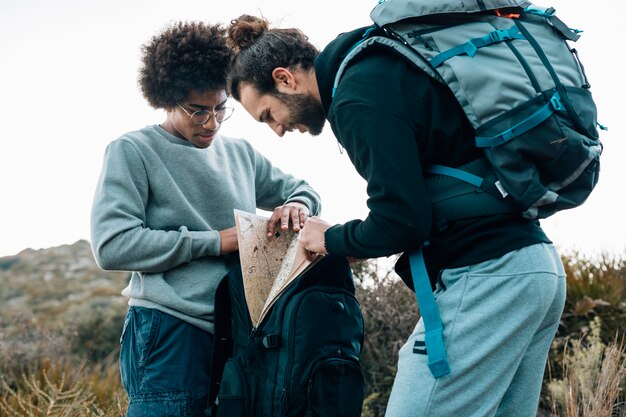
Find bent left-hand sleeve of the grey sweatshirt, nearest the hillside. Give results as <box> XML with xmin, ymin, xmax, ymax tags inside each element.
<box><xmin>91</xmin><ymin>139</ymin><xmax>220</xmax><ymax>272</ymax></box>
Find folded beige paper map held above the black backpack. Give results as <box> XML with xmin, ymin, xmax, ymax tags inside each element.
<box><xmin>235</xmin><ymin>210</ymin><xmax>322</xmax><ymax>327</ymax></box>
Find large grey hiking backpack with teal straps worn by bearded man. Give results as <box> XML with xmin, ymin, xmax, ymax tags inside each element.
<box><xmin>333</xmin><ymin>0</ymin><xmax>602</xmax><ymax>378</ymax></box>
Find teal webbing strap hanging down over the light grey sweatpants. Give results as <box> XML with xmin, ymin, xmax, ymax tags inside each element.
<box><xmin>409</xmin><ymin>249</ymin><xmax>450</xmax><ymax>378</ymax></box>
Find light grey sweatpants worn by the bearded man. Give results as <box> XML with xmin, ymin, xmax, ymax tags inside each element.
<box><xmin>385</xmin><ymin>244</ymin><xmax>565</xmax><ymax>417</ymax></box>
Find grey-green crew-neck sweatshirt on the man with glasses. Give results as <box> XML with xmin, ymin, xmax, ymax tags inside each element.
<box><xmin>91</xmin><ymin>125</ymin><xmax>320</xmax><ymax>332</ymax></box>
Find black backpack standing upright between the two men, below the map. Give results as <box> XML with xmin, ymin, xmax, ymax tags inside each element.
<box><xmin>208</xmin><ymin>256</ymin><xmax>364</xmax><ymax>417</ymax></box>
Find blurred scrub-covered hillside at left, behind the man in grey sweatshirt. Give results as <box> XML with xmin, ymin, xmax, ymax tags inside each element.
<box><xmin>0</xmin><ymin>240</ymin><xmax>129</xmax><ymax>366</ymax></box>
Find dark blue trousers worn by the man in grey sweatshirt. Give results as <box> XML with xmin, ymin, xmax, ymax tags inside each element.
<box><xmin>120</xmin><ymin>307</ymin><xmax>213</xmax><ymax>417</ymax></box>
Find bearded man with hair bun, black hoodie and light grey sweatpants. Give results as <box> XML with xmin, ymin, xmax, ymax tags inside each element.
<box><xmin>228</xmin><ymin>15</ymin><xmax>565</xmax><ymax>417</ymax></box>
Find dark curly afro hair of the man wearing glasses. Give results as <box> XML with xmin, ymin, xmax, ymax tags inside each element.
<box><xmin>138</xmin><ymin>22</ymin><xmax>232</xmax><ymax>109</ymax></box>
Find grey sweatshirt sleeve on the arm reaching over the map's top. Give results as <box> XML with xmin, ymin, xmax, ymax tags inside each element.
<box><xmin>249</xmin><ymin>146</ymin><xmax>321</xmax><ymax>216</ymax></box>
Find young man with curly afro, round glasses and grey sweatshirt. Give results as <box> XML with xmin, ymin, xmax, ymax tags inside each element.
<box><xmin>91</xmin><ymin>22</ymin><xmax>320</xmax><ymax>417</ymax></box>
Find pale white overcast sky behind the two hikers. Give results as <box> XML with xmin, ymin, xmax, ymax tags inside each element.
<box><xmin>0</xmin><ymin>0</ymin><xmax>626</xmax><ymax>257</ymax></box>
